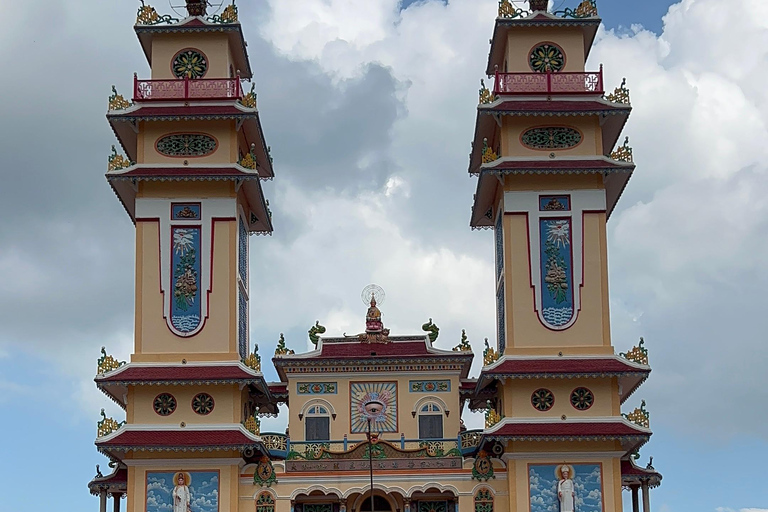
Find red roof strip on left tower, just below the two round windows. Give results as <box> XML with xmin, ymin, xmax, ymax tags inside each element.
<box><xmin>96</xmin><ymin>430</ymin><xmax>258</xmax><ymax>449</ymax></box>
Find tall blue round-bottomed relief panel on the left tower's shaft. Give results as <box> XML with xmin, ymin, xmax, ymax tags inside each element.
<box><xmin>171</xmin><ymin>226</ymin><xmax>201</xmax><ymax>335</ymax></box>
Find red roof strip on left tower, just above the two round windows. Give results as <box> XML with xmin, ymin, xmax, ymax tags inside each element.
<box><xmin>95</xmin><ymin>365</ymin><xmax>261</xmax><ymax>383</ymax></box>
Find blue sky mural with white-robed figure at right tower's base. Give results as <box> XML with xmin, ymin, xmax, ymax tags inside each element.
<box><xmin>528</xmin><ymin>464</ymin><xmax>603</xmax><ymax>512</ymax></box>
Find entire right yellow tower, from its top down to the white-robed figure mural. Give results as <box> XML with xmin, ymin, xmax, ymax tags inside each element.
<box><xmin>469</xmin><ymin>0</ymin><xmax>661</xmax><ymax>512</ymax></box>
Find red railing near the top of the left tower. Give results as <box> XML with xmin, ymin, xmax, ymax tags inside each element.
<box><xmin>133</xmin><ymin>74</ymin><xmax>243</xmax><ymax>101</ymax></box>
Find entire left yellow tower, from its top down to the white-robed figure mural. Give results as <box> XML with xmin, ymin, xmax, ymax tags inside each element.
<box><xmin>89</xmin><ymin>0</ymin><xmax>277</xmax><ymax>512</ymax></box>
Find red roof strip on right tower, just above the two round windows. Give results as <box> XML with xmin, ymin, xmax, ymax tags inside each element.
<box><xmin>482</xmin><ymin>357</ymin><xmax>651</xmax><ymax>376</ymax></box>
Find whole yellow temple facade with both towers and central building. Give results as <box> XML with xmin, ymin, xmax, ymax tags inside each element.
<box><xmin>89</xmin><ymin>0</ymin><xmax>661</xmax><ymax>512</ymax></box>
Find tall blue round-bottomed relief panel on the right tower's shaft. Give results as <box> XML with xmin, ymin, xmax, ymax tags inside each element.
<box><xmin>539</xmin><ymin>218</ymin><xmax>574</xmax><ymax>328</ymax></box>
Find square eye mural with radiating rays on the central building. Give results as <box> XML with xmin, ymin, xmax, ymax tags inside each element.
<box><xmin>349</xmin><ymin>382</ymin><xmax>397</xmax><ymax>433</ymax></box>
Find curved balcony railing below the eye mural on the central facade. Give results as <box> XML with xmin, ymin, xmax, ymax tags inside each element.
<box><xmin>261</xmin><ymin>430</ymin><xmax>482</xmax><ymax>460</ymax></box>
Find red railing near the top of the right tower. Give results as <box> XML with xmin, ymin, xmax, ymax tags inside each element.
<box><xmin>493</xmin><ymin>66</ymin><xmax>605</xmax><ymax>95</ymax></box>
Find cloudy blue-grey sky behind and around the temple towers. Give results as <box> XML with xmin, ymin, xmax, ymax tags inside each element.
<box><xmin>0</xmin><ymin>0</ymin><xmax>768</xmax><ymax>512</ymax></box>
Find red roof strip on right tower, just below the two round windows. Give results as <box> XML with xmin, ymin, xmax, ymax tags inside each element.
<box><xmin>485</xmin><ymin>421</ymin><xmax>651</xmax><ymax>438</ymax></box>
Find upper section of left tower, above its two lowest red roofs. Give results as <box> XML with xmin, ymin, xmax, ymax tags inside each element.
<box><xmin>107</xmin><ymin>0</ymin><xmax>273</xmax><ymax>362</ymax></box>
